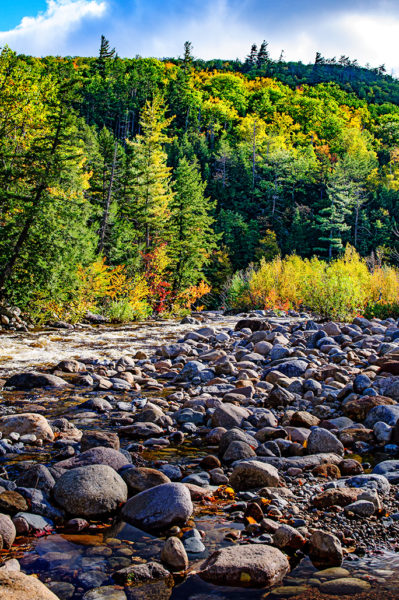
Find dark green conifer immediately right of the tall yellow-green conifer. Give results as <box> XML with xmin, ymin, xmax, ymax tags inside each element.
<box><xmin>170</xmin><ymin>158</ymin><xmax>217</xmax><ymax>291</ymax></box>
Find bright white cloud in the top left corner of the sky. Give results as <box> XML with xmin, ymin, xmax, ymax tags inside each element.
<box><xmin>0</xmin><ymin>0</ymin><xmax>107</xmax><ymax>55</ymax></box>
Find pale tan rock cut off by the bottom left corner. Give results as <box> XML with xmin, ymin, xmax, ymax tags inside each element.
<box><xmin>0</xmin><ymin>571</ymin><xmax>58</xmax><ymax>600</ymax></box>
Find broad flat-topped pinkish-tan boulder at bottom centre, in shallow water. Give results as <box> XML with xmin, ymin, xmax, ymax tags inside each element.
<box><xmin>199</xmin><ymin>544</ymin><xmax>290</xmax><ymax>587</ymax></box>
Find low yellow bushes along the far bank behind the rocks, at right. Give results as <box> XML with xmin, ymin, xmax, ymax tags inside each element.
<box><xmin>225</xmin><ymin>246</ymin><xmax>399</xmax><ymax>319</ymax></box>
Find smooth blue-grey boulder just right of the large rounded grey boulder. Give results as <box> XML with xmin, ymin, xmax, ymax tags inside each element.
<box><xmin>122</xmin><ymin>483</ymin><xmax>193</xmax><ymax>530</ymax></box>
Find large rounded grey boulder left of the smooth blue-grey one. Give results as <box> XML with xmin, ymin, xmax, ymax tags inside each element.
<box><xmin>53</xmin><ymin>464</ymin><xmax>127</xmax><ymax>518</ymax></box>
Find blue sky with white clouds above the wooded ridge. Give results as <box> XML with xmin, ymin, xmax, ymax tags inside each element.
<box><xmin>0</xmin><ymin>0</ymin><xmax>399</xmax><ymax>76</ymax></box>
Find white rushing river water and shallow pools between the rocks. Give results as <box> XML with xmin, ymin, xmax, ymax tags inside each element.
<box><xmin>0</xmin><ymin>314</ymin><xmax>399</xmax><ymax>600</ymax></box>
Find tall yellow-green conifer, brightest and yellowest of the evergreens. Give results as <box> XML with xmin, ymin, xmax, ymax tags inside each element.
<box><xmin>122</xmin><ymin>97</ymin><xmax>174</xmax><ymax>250</ymax></box>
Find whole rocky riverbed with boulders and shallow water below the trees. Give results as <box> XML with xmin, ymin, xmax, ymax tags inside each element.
<box><xmin>0</xmin><ymin>312</ymin><xmax>399</xmax><ymax>600</ymax></box>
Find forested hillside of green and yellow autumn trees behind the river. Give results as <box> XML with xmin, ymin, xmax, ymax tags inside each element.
<box><xmin>0</xmin><ymin>38</ymin><xmax>399</xmax><ymax>318</ymax></box>
